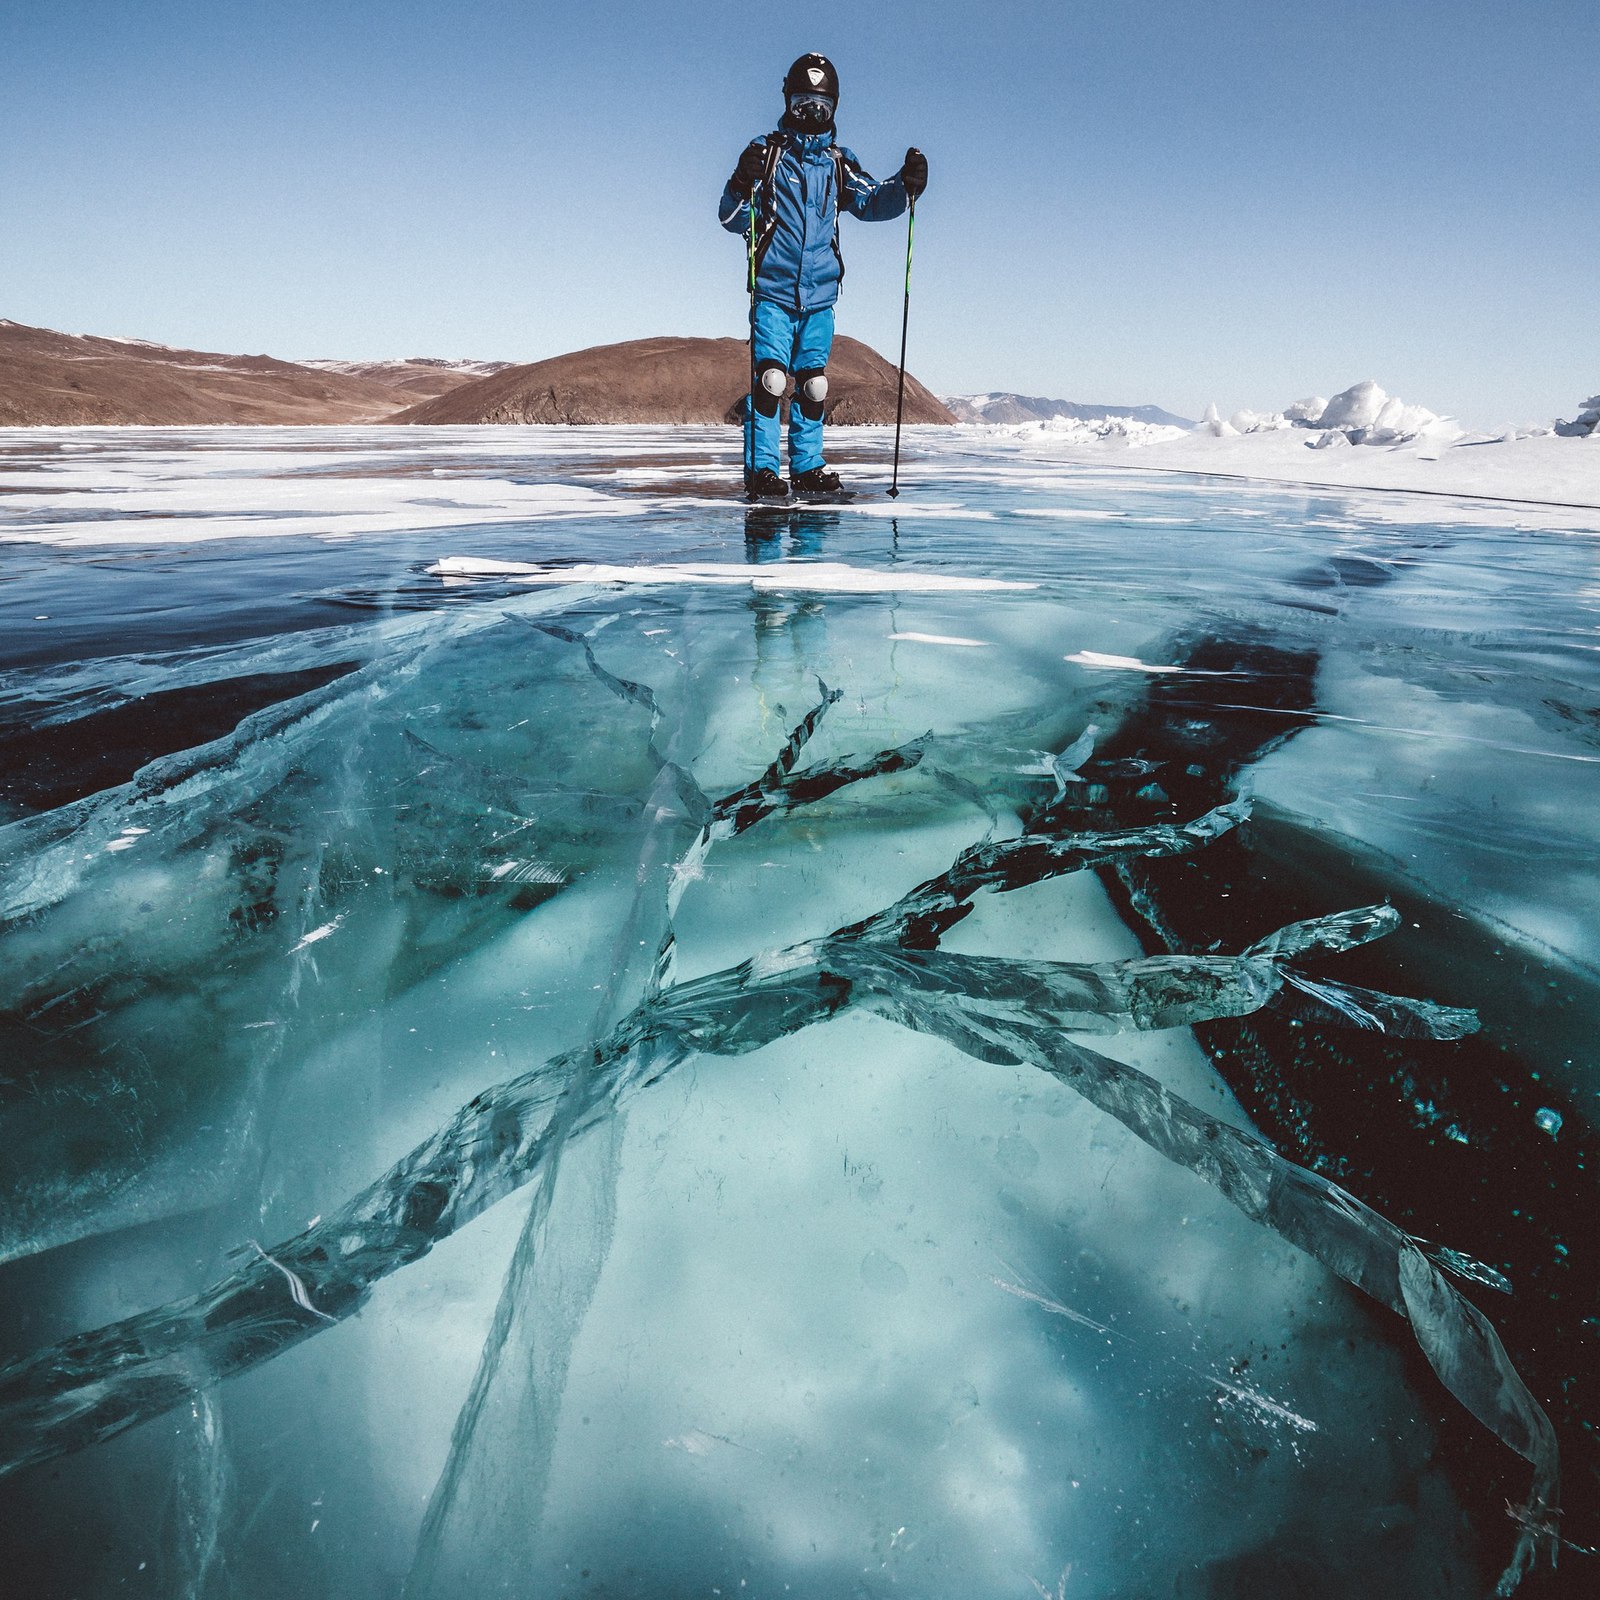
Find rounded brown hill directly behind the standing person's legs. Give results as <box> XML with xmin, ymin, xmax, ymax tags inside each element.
<box><xmin>390</xmin><ymin>338</ymin><xmax>955</xmax><ymax>424</ymax></box>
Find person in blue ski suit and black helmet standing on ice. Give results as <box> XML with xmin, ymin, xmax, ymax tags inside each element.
<box><xmin>717</xmin><ymin>54</ymin><xmax>928</xmax><ymax>499</ymax></box>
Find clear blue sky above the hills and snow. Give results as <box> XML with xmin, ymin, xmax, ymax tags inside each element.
<box><xmin>0</xmin><ymin>0</ymin><xmax>1600</xmax><ymax>424</ymax></box>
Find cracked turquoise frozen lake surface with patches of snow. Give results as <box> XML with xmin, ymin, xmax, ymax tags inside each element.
<box><xmin>0</xmin><ymin>429</ymin><xmax>1600</xmax><ymax>1600</ymax></box>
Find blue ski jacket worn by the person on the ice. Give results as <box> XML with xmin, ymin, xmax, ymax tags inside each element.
<box><xmin>717</xmin><ymin>126</ymin><xmax>906</xmax><ymax>312</ymax></box>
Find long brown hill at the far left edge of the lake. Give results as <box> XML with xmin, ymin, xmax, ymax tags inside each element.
<box><xmin>0</xmin><ymin>320</ymin><xmax>428</xmax><ymax>427</ymax></box>
